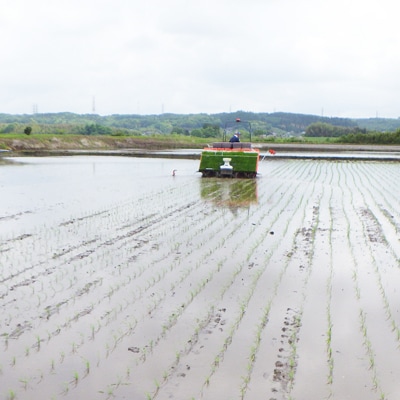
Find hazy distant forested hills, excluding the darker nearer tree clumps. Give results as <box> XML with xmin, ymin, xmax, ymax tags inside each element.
<box><xmin>0</xmin><ymin>111</ymin><xmax>400</xmax><ymax>136</ymax></box>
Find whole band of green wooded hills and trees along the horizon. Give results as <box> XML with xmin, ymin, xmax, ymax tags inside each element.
<box><xmin>0</xmin><ymin>111</ymin><xmax>400</xmax><ymax>143</ymax></box>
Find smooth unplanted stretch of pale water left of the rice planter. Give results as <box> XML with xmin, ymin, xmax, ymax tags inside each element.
<box><xmin>0</xmin><ymin>156</ymin><xmax>203</xmax><ymax>238</ymax></box>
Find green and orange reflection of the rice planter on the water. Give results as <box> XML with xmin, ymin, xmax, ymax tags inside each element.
<box><xmin>200</xmin><ymin>178</ymin><xmax>258</xmax><ymax>209</ymax></box>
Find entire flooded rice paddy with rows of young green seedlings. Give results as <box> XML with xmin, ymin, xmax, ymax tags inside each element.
<box><xmin>0</xmin><ymin>156</ymin><xmax>400</xmax><ymax>400</ymax></box>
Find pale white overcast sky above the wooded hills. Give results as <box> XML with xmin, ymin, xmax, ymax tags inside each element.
<box><xmin>0</xmin><ymin>0</ymin><xmax>400</xmax><ymax>118</ymax></box>
